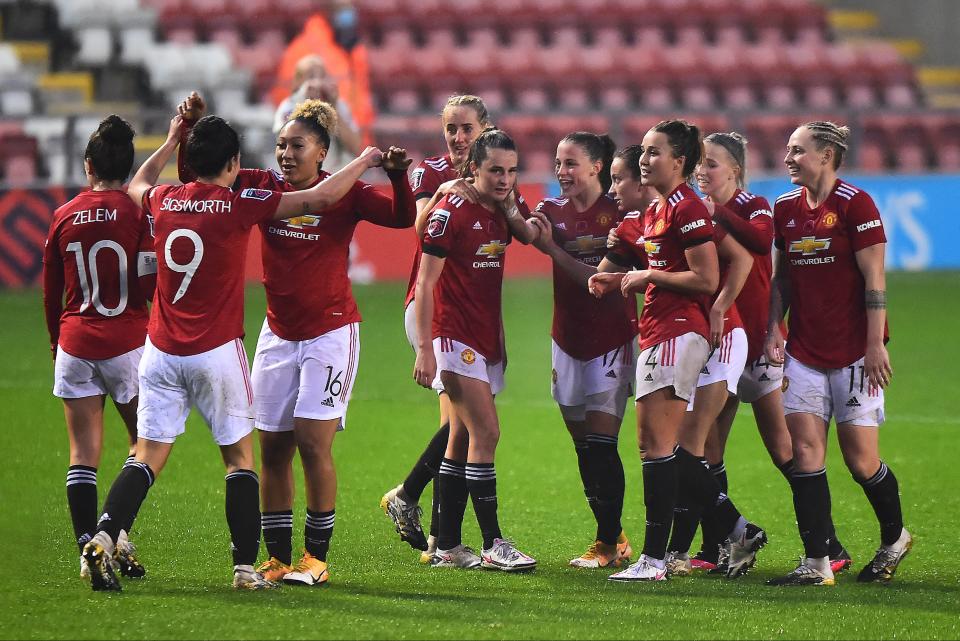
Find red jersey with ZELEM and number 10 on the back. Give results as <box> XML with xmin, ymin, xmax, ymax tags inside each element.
<box><xmin>43</xmin><ymin>190</ymin><xmax>156</xmax><ymax>360</ymax></box>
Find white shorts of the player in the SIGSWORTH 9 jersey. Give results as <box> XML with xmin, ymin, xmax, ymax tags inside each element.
<box><xmin>137</xmin><ymin>337</ymin><xmax>253</xmax><ymax>445</ymax></box>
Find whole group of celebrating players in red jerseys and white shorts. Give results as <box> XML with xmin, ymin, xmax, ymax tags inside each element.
<box><xmin>43</xmin><ymin>94</ymin><xmax>912</xmax><ymax>590</ymax></box>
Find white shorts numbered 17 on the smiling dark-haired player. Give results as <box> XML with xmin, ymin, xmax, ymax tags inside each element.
<box><xmin>550</xmin><ymin>340</ymin><xmax>637</xmax><ymax>421</ymax></box>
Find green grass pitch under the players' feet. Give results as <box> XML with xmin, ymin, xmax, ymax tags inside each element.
<box><xmin>0</xmin><ymin>273</ymin><xmax>960</xmax><ymax>639</ymax></box>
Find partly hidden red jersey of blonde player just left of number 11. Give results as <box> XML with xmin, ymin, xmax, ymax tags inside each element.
<box><xmin>713</xmin><ymin>189</ymin><xmax>783</xmax><ymax>362</ymax></box>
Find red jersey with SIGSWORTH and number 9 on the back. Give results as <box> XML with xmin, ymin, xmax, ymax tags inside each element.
<box><xmin>143</xmin><ymin>182</ymin><xmax>281</xmax><ymax>356</ymax></box>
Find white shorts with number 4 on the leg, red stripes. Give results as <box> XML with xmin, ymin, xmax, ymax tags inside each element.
<box><xmin>636</xmin><ymin>332</ymin><xmax>710</xmax><ymax>401</ymax></box>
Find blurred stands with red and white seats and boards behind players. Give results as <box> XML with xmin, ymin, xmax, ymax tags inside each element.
<box><xmin>0</xmin><ymin>0</ymin><xmax>960</xmax><ymax>287</ymax></box>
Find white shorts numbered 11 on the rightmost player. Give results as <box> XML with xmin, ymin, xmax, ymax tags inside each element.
<box><xmin>783</xmin><ymin>355</ymin><xmax>884</xmax><ymax>427</ymax></box>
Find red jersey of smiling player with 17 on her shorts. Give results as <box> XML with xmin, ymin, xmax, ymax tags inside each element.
<box><xmin>537</xmin><ymin>194</ymin><xmax>637</xmax><ymax>361</ymax></box>
